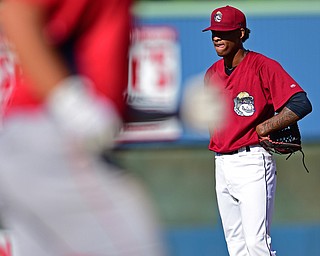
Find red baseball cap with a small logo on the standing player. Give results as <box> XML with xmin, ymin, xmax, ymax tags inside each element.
<box><xmin>202</xmin><ymin>5</ymin><xmax>247</xmax><ymax>32</ymax></box>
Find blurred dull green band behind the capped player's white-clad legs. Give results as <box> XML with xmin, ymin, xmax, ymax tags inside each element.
<box><xmin>115</xmin><ymin>144</ymin><xmax>320</xmax><ymax>226</ymax></box>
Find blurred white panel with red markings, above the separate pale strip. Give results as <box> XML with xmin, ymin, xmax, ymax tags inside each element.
<box><xmin>128</xmin><ymin>26</ymin><xmax>181</xmax><ymax>111</ymax></box>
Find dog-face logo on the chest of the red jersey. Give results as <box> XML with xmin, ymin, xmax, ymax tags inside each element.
<box><xmin>233</xmin><ymin>92</ymin><xmax>255</xmax><ymax>116</ymax></box>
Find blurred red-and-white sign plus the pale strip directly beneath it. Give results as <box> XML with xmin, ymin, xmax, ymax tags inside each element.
<box><xmin>119</xmin><ymin>26</ymin><xmax>182</xmax><ymax>142</ymax></box>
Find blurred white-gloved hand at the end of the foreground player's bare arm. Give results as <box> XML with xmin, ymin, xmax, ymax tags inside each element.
<box><xmin>47</xmin><ymin>76</ymin><xmax>121</xmax><ymax>152</ymax></box>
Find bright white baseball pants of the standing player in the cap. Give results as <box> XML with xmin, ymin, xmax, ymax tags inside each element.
<box><xmin>215</xmin><ymin>145</ymin><xmax>276</xmax><ymax>256</ymax></box>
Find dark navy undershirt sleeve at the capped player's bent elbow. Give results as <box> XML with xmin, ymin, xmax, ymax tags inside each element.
<box><xmin>285</xmin><ymin>92</ymin><xmax>312</xmax><ymax>119</ymax></box>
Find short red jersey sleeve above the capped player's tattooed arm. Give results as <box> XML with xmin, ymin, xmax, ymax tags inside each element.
<box><xmin>260</xmin><ymin>59</ymin><xmax>304</xmax><ymax>111</ymax></box>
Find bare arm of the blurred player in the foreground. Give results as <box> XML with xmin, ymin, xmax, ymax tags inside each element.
<box><xmin>0</xmin><ymin>0</ymin><xmax>69</xmax><ymax>98</ymax></box>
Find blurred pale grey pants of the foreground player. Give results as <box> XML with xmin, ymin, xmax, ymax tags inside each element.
<box><xmin>0</xmin><ymin>113</ymin><xmax>168</xmax><ymax>256</ymax></box>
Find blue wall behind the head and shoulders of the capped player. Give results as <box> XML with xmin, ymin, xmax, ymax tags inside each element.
<box><xmin>134</xmin><ymin>13</ymin><xmax>320</xmax><ymax>141</ymax></box>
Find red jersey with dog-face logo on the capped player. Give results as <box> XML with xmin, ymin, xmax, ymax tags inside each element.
<box><xmin>205</xmin><ymin>52</ymin><xmax>303</xmax><ymax>153</ymax></box>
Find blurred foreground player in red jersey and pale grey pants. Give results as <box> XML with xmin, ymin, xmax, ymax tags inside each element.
<box><xmin>0</xmin><ymin>0</ymin><xmax>168</xmax><ymax>256</ymax></box>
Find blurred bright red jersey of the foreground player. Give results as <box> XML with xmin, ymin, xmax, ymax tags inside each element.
<box><xmin>8</xmin><ymin>0</ymin><xmax>131</xmax><ymax>116</ymax></box>
